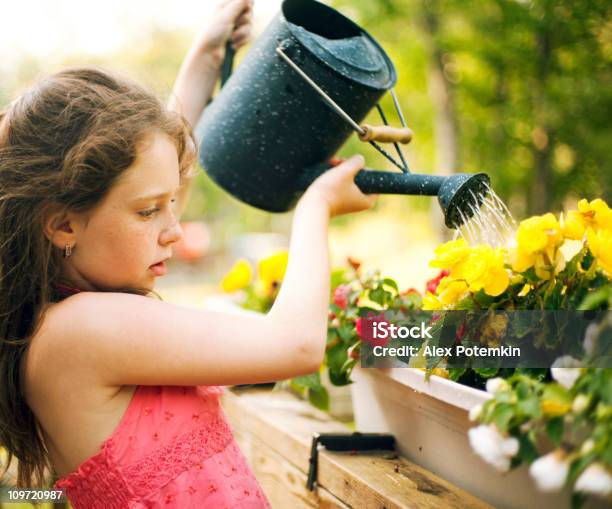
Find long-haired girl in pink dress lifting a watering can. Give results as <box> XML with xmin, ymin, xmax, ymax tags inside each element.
<box><xmin>0</xmin><ymin>0</ymin><xmax>376</xmax><ymax>509</ymax></box>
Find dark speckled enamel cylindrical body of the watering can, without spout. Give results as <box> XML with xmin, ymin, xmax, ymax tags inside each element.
<box><xmin>198</xmin><ymin>0</ymin><xmax>396</xmax><ymax>212</ymax></box>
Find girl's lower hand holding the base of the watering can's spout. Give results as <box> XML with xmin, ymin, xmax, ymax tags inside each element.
<box><xmin>300</xmin><ymin>154</ymin><xmax>378</xmax><ymax>217</ymax></box>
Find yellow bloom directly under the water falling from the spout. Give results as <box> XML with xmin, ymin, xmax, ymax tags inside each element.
<box><xmin>451</xmin><ymin>244</ymin><xmax>510</xmax><ymax>297</ymax></box>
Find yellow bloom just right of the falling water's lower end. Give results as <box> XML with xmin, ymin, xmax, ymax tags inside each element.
<box><xmin>511</xmin><ymin>212</ymin><xmax>563</xmax><ymax>272</ymax></box>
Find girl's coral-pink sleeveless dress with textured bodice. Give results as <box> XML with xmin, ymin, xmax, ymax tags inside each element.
<box><xmin>54</xmin><ymin>385</ymin><xmax>270</xmax><ymax>509</ymax></box>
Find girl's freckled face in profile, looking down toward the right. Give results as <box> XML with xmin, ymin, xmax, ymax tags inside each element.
<box><xmin>62</xmin><ymin>133</ymin><xmax>182</xmax><ymax>290</ymax></box>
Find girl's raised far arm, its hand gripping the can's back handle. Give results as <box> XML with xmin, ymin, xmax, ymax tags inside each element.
<box><xmin>168</xmin><ymin>0</ymin><xmax>253</xmax><ymax>217</ymax></box>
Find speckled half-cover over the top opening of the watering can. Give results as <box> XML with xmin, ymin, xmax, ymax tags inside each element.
<box><xmin>287</xmin><ymin>22</ymin><xmax>397</xmax><ymax>90</ymax></box>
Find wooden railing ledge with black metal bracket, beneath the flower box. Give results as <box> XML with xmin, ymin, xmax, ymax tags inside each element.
<box><xmin>222</xmin><ymin>387</ymin><xmax>491</xmax><ymax>509</ymax></box>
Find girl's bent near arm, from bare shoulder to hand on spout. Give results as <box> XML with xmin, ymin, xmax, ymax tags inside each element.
<box><xmin>40</xmin><ymin>156</ymin><xmax>376</xmax><ymax>387</ymax></box>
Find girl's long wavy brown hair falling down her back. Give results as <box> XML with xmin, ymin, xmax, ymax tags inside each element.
<box><xmin>0</xmin><ymin>68</ymin><xmax>196</xmax><ymax>488</ymax></box>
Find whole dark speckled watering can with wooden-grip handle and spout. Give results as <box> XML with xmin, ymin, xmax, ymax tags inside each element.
<box><xmin>198</xmin><ymin>0</ymin><xmax>489</xmax><ymax>228</ymax></box>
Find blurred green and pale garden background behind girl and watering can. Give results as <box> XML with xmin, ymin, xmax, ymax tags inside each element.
<box><xmin>0</xmin><ymin>0</ymin><xmax>612</xmax><ymax>305</ymax></box>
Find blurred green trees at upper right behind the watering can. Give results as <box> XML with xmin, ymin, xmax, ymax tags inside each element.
<box><xmin>333</xmin><ymin>0</ymin><xmax>612</xmax><ymax>216</ymax></box>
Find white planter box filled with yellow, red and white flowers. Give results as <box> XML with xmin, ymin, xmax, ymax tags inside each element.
<box><xmin>326</xmin><ymin>200</ymin><xmax>612</xmax><ymax>508</ymax></box>
